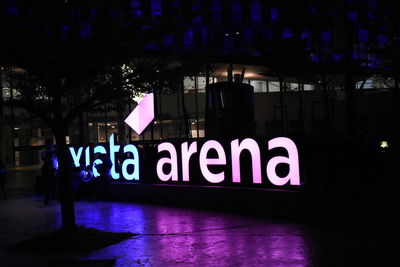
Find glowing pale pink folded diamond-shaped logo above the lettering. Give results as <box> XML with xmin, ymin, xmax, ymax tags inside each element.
<box><xmin>125</xmin><ymin>93</ymin><xmax>154</xmax><ymax>135</ymax></box>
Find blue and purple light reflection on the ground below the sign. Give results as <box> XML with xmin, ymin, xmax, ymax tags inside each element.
<box><xmin>77</xmin><ymin>203</ymin><xmax>309</xmax><ymax>266</ymax></box>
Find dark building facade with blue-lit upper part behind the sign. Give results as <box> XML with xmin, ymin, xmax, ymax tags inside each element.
<box><xmin>0</xmin><ymin>0</ymin><xmax>396</xmax><ymax>165</ymax></box>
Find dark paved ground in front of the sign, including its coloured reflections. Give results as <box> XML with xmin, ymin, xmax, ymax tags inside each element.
<box><xmin>0</xmin><ymin>168</ymin><xmax>399</xmax><ymax>266</ymax></box>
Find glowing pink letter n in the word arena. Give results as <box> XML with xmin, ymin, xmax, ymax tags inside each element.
<box><xmin>231</xmin><ymin>138</ymin><xmax>261</xmax><ymax>184</ymax></box>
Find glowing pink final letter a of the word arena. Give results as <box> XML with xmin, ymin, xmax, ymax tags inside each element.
<box><xmin>267</xmin><ymin>137</ymin><xmax>300</xmax><ymax>186</ymax></box>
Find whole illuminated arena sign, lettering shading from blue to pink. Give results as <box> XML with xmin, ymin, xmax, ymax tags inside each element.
<box><xmin>69</xmin><ymin>134</ymin><xmax>300</xmax><ymax>186</ymax></box>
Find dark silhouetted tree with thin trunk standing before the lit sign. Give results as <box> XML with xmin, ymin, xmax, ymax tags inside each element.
<box><xmin>0</xmin><ymin>1</ymin><xmax>191</xmax><ymax>230</ymax></box>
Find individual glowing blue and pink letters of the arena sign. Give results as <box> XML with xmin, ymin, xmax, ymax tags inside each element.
<box><xmin>69</xmin><ymin>134</ymin><xmax>300</xmax><ymax>186</ymax></box>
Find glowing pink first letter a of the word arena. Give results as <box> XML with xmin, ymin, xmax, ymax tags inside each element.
<box><xmin>157</xmin><ymin>143</ymin><xmax>178</xmax><ymax>182</ymax></box>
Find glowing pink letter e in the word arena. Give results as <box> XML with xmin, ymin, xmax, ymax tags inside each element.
<box><xmin>199</xmin><ymin>140</ymin><xmax>226</xmax><ymax>183</ymax></box>
